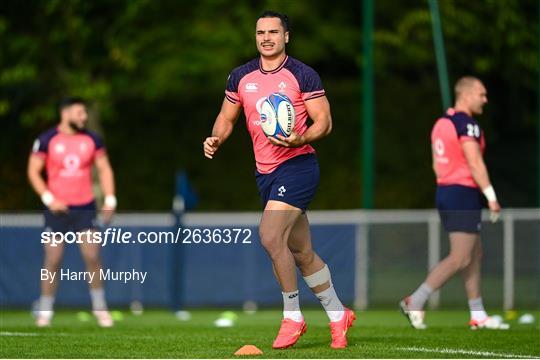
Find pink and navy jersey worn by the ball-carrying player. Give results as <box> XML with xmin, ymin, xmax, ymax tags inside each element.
<box><xmin>225</xmin><ymin>56</ymin><xmax>325</xmax><ymax>174</ymax></box>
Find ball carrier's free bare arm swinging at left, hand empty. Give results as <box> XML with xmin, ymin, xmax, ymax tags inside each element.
<box><xmin>203</xmin><ymin>98</ymin><xmax>242</xmax><ymax>159</ymax></box>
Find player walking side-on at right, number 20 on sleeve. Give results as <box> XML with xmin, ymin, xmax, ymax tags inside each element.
<box><xmin>400</xmin><ymin>76</ymin><xmax>508</xmax><ymax>329</ymax></box>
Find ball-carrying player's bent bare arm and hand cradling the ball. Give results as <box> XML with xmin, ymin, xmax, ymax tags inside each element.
<box><xmin>268</xmin><ymin>96</ymin><xmax>332</xmax><ymax>147</ymax></box>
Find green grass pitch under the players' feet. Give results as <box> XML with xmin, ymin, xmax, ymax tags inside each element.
<box><xmin>0</xmin><ymin>310</ymin><xmax>540</xmax><ymax>358</ymax></box>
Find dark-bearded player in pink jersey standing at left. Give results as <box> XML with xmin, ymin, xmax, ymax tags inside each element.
<box><xmin>28</xmin><ymin>98</ymin><xmax>116</xmax><ymax>327</ymax></box>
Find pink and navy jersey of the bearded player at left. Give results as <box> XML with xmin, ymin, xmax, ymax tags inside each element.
<box><xmin>32</xmin><ymin>128</ymin><xmax>105</xmax><ymax>205</ymax></box>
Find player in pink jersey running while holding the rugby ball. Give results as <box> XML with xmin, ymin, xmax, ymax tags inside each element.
<box><xmin>203</xmin><ymin>11</ymin><xmax>355</xmax><ymax>349</ymax></box>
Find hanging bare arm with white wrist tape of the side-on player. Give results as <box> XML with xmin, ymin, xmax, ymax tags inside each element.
<box><xmin>461</xmin><ymin>141</ymin><xmax>501</xmax><ymax>221</ymax></box>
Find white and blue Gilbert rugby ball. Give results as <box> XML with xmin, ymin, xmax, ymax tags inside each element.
<box><xmin>260</xmin><ymin>93</ymin><xmax>296</xmax><ymax>138</ymax></box>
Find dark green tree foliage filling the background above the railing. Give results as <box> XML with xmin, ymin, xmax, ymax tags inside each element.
<box><xmin>0</xmin><ymin>0</ymin><xmax>538</xmax><ymax>210</ymax></box>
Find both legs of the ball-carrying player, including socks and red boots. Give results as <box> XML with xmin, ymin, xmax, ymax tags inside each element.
<box><xmin>259</xmin><ymin>195</ymin><xmax>355</xmax><ymax>348</ymax></box>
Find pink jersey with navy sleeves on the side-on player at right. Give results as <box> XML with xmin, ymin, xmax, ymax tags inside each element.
<box><xmin>431</xmin><ymin>108</ymin><xmax>485</xmax><ymax>188</ymax></box>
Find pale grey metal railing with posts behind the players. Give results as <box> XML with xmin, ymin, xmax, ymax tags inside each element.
<box><xmin>0</xmin><ymin>208</ymin><xmax>540</xmax><ymax>309</ymax></box>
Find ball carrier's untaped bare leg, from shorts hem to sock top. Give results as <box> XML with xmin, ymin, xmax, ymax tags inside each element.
<box><xmin>259</xmin><ymin>200</ymin><xmax>301</xmax><ymax>292</ymax></box>
